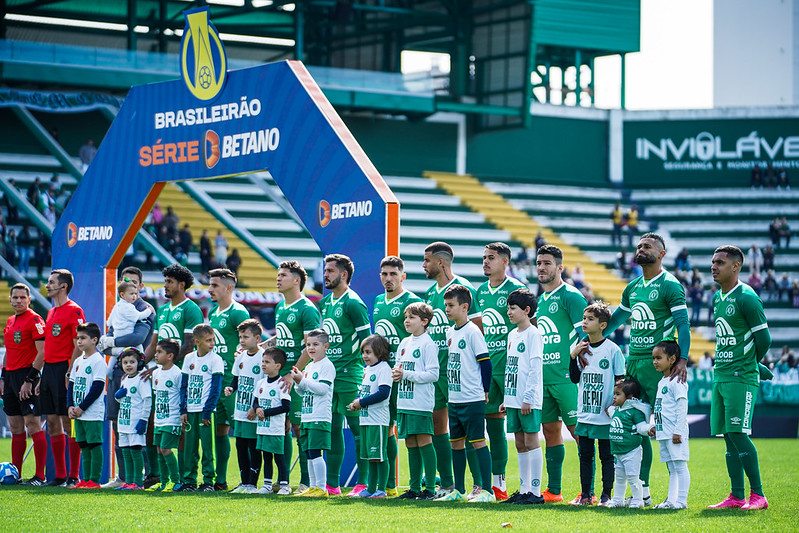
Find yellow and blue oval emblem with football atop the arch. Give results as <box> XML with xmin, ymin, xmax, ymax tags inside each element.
<box><xmin>180</xmin><ymin>7</ymin><xmax>227</xmax><ymax>100</ymax></box>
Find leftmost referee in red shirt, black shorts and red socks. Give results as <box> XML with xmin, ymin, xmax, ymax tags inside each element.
<box><xmin>0</xmin><ymin>283</ymin><xmax>47</xmax><ymax>487</ymax></box>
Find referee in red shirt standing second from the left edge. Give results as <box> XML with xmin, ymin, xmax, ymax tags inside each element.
<box><xmin>39</xmin><ymin>269</ymin><xmax>86</xmax><ymax>487</ymax></box>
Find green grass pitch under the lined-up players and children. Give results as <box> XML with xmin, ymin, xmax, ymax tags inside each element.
<box><xmin>0</xmin><ymin>439</ymin><xmax>799</xmax><ymax>533</ymax></box>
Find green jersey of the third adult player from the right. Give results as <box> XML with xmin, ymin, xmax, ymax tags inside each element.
<box><xmin>535</xmin><ymin>283</ymin><xmax>588</xmax><ymax>385</ymax></box>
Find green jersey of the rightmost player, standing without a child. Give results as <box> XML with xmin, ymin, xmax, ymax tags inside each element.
<box><xmin>713</xmin><ymin>281</ymin><xmax>768</xmax><ymax>385</ymax></box>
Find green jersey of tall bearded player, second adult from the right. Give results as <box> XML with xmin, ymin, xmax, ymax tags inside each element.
<box><xmin>619</xmin><ymin>270</ymin><xmax>688</xmax><ymax>359</ymax></box>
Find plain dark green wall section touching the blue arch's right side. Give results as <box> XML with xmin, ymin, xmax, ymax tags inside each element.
<box><xmin>343</xmin><ymin>116</ymin><xmax>458</xmax><ymax>176</ymax></box>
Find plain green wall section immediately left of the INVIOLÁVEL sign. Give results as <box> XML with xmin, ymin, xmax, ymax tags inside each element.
<box><xmin>466</xmin><ymin>116</ymin><xmax>608</xmax><ymax>186</ymax></box>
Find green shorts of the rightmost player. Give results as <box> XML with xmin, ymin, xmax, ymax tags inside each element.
<box><xmin>710</xmin><ymin>383</ymin><xmax>760</xmax><ymax>435</ymax></box>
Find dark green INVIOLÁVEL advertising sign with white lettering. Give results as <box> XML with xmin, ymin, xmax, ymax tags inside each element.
<box><xmin>624</xmin><ymin>118</ymin><xmax>799</xmax><ymax>187</ymax></box>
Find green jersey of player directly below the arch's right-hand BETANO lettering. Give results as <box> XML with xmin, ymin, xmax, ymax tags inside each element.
<box><xmin>320</xmin><ymin>289</ymin><xmax>371</xmax><ymax>384</ymax></box>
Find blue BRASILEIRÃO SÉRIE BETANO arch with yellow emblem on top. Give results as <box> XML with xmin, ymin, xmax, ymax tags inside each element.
<box><xmin>53</xmin><ymin>8</ymin><xmax>399</xmax><ymax>323</ymax></box>
